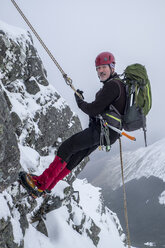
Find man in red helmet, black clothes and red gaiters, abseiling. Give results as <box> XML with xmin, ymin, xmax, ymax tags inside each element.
<box><xmin>20</xmin><ymin>52</ymin><xmax>126</xmax><ymax>197</ymax></box>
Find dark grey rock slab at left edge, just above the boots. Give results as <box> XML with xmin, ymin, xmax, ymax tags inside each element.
<box><xmin>0</xmin><ymin>90</ymin><xmax>20</xmax><ymax>192</ymax></box>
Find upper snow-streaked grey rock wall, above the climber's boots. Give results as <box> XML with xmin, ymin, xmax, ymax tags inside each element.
<box><xmin>0</xmin><ymin>20</ymin><xmax>85</xmax><ymax>189</ymax></box>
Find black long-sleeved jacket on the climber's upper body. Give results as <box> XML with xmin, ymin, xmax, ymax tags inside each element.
<box><xmin>76</xmin><ymin>74</ymin><xmax>126</xmax><ymax>117</ymax></box>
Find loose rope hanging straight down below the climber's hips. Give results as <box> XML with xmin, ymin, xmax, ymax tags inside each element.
<box><xmin>119</xmin><ymin>137</ymin><xmax>131</xmax><ymax>248</ymax></box>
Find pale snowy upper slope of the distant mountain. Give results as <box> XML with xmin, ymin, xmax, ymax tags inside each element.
<box><xmin>92</xmin><ymin>139</ymin><xmax>165</xmax><ymax>189</ymax></box>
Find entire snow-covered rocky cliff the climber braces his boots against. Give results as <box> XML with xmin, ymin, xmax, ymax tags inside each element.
<box><xmin>0</xmin><ymin>22</ymin><xmax>125</xmax><ymax>248</ymax></box>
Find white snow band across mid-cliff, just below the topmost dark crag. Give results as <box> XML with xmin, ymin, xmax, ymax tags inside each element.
<box><xmin>2</xmin><ymin>76</ymin><xmax>68</xmax><ymax>148</ymax></box>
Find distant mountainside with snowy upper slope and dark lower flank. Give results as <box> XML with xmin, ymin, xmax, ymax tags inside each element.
<box><xmin>94</xmin><ymin>139</ymin><xmax>165</xmax><ymax>248</ymax></box>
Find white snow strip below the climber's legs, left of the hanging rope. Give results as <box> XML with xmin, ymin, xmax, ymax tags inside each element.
<box><xmin>73</xmin><ymin>179</ymin><xmax>123</xmax><ymax>248</ymax></box>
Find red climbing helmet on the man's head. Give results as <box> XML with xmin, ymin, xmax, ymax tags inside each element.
<box><xmin>95</xmin><ymin>52</ymin><xmax>115</xmax><ymax>67</ymax></box>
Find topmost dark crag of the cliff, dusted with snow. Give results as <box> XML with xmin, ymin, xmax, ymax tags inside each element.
<box><xmin>0</xmin><ymin>31</ymin><xmax>48</xmax><ymax>86</ymax></box>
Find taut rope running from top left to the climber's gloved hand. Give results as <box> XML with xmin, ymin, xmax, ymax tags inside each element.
<box><xmin>11</xmin><ymin>0</ymin><xmax>82</xmax><ymax>99</ymax></box>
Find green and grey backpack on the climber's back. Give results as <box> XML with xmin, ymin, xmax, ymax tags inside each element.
<box><xmin>122</xmin><ymin>64</ymin><xmax>152</xmax><ymax>145</ymax></box>
